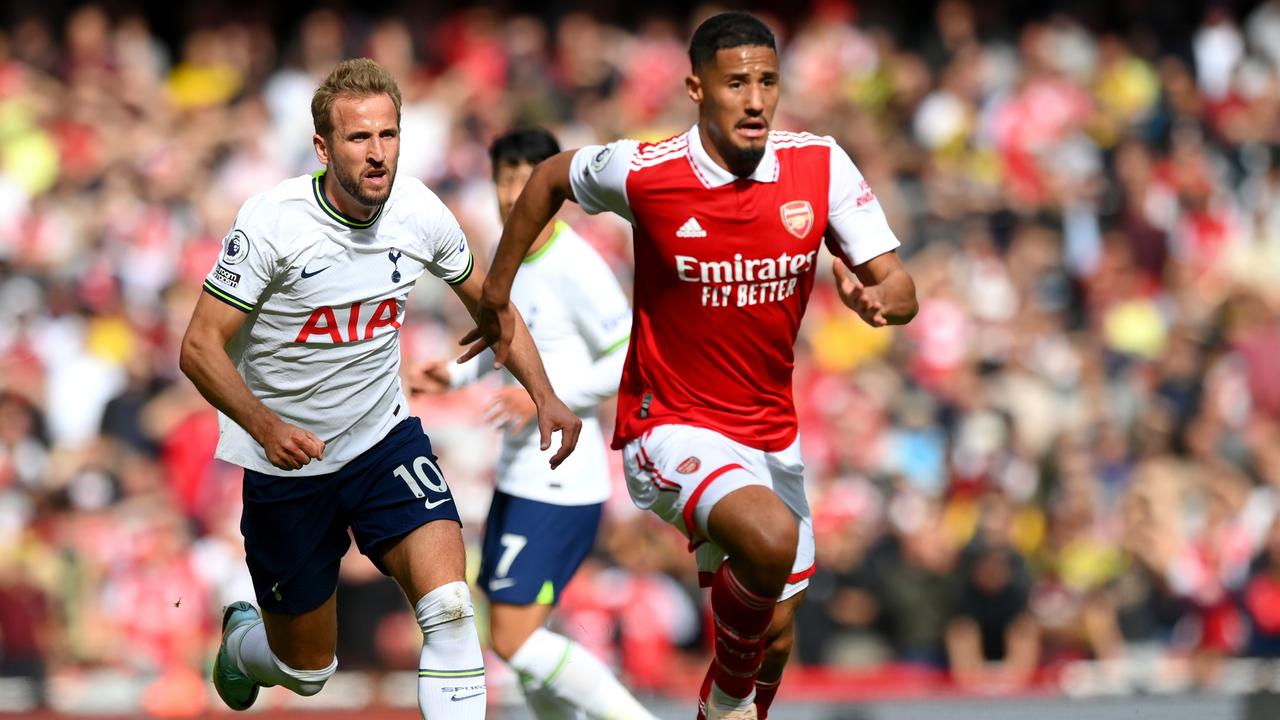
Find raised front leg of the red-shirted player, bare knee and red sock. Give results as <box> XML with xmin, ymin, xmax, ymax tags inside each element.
<box><xmin>705</xmin><ymin>486</ymin><xmax>799</xmax><ymax>710</ymax></box>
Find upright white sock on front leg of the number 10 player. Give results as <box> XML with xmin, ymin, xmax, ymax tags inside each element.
<box><xmin>415</xmin><ymin>582</ymin><xmax>488</xmax><ymax>720</ymax></box>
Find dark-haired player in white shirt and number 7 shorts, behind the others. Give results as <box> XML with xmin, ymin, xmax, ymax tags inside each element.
<box><xmin>410</xmin><ymin>128</ymin><xmax>653</xmax><ymax>720</ymax></box>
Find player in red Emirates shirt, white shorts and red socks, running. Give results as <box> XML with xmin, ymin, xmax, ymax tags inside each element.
<box><xmin>463</xmin><ymin>13</ymin><xmax>916</xmax><ymax>720</ymax></box>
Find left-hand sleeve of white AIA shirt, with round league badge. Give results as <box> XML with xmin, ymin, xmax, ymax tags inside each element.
<box><xmin>205</xmin><ymin>200</ymin><xmax>276</xmax><ymax>313</ymax></box>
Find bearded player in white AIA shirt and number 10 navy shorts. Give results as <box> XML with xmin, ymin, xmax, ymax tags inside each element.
<box><xmin>180</xmin><ymin>59</ymin><xmax>580</xmax><ymax>720</ymax></box>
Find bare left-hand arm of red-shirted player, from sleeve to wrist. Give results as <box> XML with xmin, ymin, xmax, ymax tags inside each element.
<box><xmin>484</xmin><ymin>152</ymin><xmax>573</xmax><ymax>307</ymax></box>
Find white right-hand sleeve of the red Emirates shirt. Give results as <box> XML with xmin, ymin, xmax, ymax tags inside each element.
<box><xmin>827</xmin><ymin>141</ymin><xmax>901</xmax><ymax>266</ymax></box>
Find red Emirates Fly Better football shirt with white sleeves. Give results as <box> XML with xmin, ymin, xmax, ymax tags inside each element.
<box><xmin>570</xmin><ymin>126</ymin><xmax>899</xmax><ymax>452</ymax></box>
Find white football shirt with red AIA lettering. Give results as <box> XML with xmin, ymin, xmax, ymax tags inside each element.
<box><xmin>205</xmin><ymin>170</ymin><xmax>475</xmax><ymax>475</ymax></box>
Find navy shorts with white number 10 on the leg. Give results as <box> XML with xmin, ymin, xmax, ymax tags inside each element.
<box><xmin>241</xmin><ymin>418</ymin><xmax>462</xmax><ymax>615</ymax></box>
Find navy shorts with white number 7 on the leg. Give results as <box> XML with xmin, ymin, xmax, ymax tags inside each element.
<box><xmin>476</xmin><ymin>492</ymin><xmax>604</xmax><ymax>605</ymax></box>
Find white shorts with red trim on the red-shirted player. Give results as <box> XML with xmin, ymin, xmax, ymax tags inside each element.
<box><xmin>622</xmin><ymin>425</ymin><xmax>814</xmax><ymax>601</ymax></box>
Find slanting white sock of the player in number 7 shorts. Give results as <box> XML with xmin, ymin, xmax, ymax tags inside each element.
<box><xmin>511</xmin><ymin>628</ymin><xmax>655</xmax><ymax>720</ymax></box>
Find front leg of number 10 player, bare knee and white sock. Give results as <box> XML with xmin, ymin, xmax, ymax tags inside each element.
<box><xmin>380</xmin><ymin>520</ymin><xmax>486</xmax><ymax>720</ymax></box>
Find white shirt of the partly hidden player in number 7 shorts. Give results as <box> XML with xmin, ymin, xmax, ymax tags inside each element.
<box><xmin>449</xmin><ymin>222</ymin><xmax>631</xmax><ymax>505</ymax></box>
